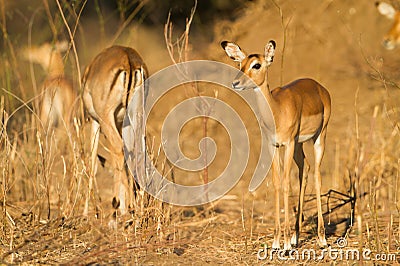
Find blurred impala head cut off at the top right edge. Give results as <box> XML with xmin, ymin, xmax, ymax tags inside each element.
<box><xmin>376</xmin><ymin>2</ymin><xmax>400</xmax><ymax>50</ymax></box>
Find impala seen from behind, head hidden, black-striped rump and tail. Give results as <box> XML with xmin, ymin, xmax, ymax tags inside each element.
<box><xmin>82</xmin><ymin>46</ymin><xmax>148</xmax><ymax>214</ymax></box>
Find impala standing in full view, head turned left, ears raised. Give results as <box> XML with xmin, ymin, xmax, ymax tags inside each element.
<box><xmin>221</xmin><ymin>41</ymin><xmax>331</xmax><ymax>250</ymax></box>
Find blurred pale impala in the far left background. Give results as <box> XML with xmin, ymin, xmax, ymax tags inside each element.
<box><xmin>22</xmin><ymin>42</ymin><xmax>77</xmax><ymax>129</ymax></box>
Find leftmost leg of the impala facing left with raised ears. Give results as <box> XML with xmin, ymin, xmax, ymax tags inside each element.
<box><xmin>272</xmin><ymin>148</ymin><xmax>281</xmax><ymax>249</ymax></box>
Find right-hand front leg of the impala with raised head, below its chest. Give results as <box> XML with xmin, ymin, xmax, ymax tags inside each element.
<box><xmin>282</xmin><ymin>141</ymin><xmax>294</xmax><ymax>250</ymax></box>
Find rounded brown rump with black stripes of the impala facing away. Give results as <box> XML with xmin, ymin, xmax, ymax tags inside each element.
<box><xmin>83</xmin><ymin>46</ymin><xmax>148</xmax><ymax>125</ymax></box>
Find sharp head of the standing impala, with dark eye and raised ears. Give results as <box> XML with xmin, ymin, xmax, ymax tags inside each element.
<box><xmin>221</xmin><ymin>40</ymin><xmax>276</xmax><ymax>90</ymax></box>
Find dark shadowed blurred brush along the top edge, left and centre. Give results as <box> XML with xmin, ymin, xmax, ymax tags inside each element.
<box><xmin>0</xmin><ymin>0</ymin><xmax>248</xmax><ymax>46</ymax></box>
